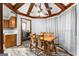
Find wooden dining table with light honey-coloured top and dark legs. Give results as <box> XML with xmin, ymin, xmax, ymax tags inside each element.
<box><xmin>36</xmin><ymin>35</ymin><xmax>56</xmax><ymax>55</ymax></box>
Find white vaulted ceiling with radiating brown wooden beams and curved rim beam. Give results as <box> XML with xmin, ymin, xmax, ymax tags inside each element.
<box><xmin>4</xmin><ymin>3</ymin><xmax>74</xmax><ymax>18</ymax></box>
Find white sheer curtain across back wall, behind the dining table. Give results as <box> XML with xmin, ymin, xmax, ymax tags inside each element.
<box><xmin>32</xmin><ymin>17</ymin><xmax>57</xmax><ymax>33</ymax></box>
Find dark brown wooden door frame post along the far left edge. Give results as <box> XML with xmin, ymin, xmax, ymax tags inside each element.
<box><xmin>0</xmin><ymin>3</ymin><xmax>4</xmax><ymax>53</ymax></box>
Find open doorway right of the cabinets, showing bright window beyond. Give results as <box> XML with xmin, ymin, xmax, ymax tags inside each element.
<box><xmin>21</xmin><ymin>18</ymin><xmax>31</xmax><ymax>47</ymax></box>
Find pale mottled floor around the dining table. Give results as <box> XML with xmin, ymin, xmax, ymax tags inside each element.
<box><xmin>4</xmin><ymin>40</ymin><xmax>70</xmax><ymax>56</ymax></box>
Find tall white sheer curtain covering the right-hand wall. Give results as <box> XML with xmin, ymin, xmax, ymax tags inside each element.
<box><xmin>58</xmin><ymin>7</ymin><xmax>76</xmax><ymax>55</ymax></box>
